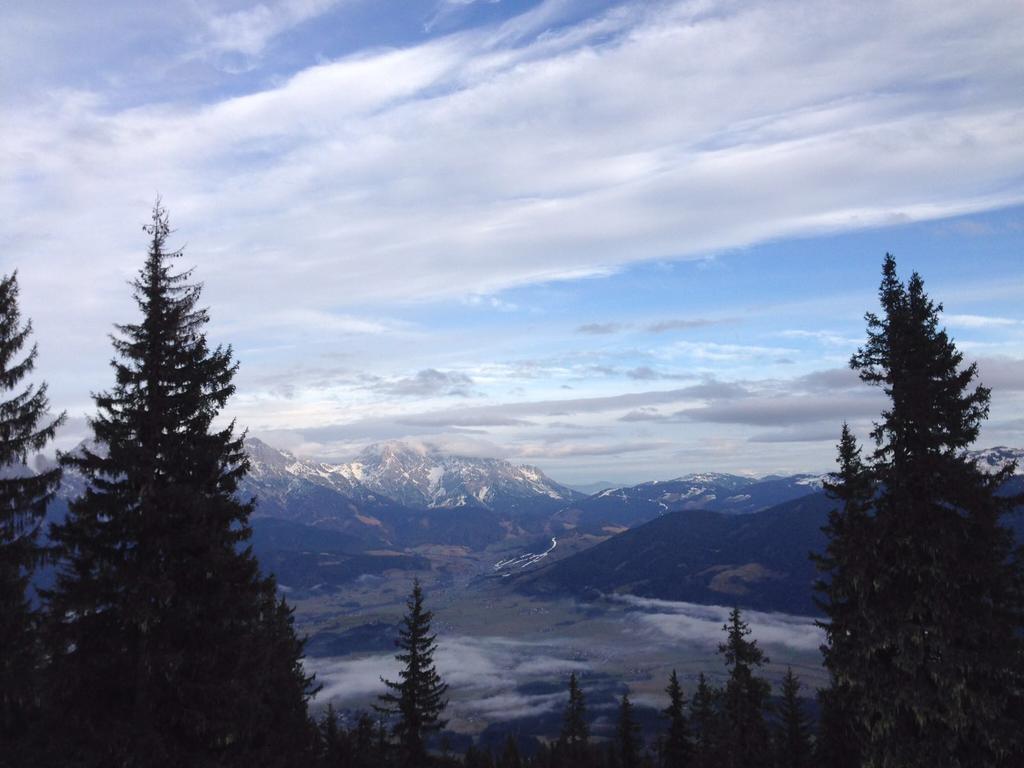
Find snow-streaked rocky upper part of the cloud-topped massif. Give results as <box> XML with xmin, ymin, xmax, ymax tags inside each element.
<box><xmin>241</xmin><ymin>439</ymin><xmax>584</xmax><ymax>515</ymax></box>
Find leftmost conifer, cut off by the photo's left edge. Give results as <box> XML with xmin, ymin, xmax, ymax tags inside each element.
<box><xmin>0</xmin><ymin>273</ymin><xmax>65</xmax><ymax>762</ymax></box>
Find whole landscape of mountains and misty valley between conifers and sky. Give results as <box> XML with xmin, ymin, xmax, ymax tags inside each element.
<box><xmin>226</xmin><ymin>443</ymin><xmax>1024</xmax><ymax>744</ymax></box>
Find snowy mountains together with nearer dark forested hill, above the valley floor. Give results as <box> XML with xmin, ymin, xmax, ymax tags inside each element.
<box><xmin>36</xmin><ymin>439</ymin><xmax>1024</xmax><ymax>613</ymax></box>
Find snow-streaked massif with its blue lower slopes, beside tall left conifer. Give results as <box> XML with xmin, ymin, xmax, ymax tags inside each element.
<box><xmin>241</xmin><ymin>438</ymin><xmax>584</xmax><ymax>550</ymax></box>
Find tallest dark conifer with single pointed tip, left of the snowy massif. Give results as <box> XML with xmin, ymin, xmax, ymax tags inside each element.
<box><xmin>48</xmin><ymin>203</ymin><xmax>312</xmax><ymax>766</ymax></box>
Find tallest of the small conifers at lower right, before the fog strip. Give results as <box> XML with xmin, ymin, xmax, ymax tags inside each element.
<box><xmin>718</xmin><ymin>608</ymin><xmax>771</xmax><ymax>768</ymax></box>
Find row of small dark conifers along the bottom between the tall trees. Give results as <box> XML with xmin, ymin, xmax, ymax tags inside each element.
<box><xmin>317</xmin><ymin>584</ymin><xmax>815</xmax><ymax>768</ymax></box>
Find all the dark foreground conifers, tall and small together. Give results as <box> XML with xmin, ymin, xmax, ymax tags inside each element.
<box><xmin>0</xmin><ymin>202</ymin><xmax>1024</xmax><ymax>768</ymax></box>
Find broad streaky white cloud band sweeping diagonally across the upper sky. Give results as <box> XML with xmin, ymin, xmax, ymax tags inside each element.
<box><xmin>8</xmin><ymin>2</ymin><xmax>1024</xmax><ymax>346</ymax></box>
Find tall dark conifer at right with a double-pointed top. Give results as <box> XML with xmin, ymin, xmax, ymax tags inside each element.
<box><xmin>826</xmin><ymin>255</ymin><xmax>1024</xmax><ymax>767</ymax></box>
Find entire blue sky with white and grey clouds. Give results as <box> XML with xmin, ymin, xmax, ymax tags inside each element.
<box><xmin>0</xmin><ymin>0</ymin><xmax>1024</xmax><ymax>483</ymax></box>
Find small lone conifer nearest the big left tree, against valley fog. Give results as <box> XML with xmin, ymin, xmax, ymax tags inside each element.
<box><xmin>376</xmin><ymin>579</ymin><xmax>447</xmax><ymax>768</ymax></box>
